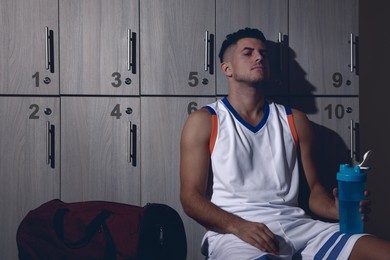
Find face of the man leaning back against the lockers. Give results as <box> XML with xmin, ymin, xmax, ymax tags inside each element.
<box><xmin>222</xmin><ymin>38</ymin><xmax>270</xmax><ymax>83</ymax></box>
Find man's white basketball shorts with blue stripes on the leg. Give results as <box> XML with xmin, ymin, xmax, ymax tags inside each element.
<box><xmin>205</xmin><ymin>219</ymin><xmax>367</xmax><ymax>260</ymax></box>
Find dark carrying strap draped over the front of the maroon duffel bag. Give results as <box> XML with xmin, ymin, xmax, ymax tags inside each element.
<box><xmin>54</xmin><ymin>208</ymin><xmax>116</xmax><ymax>259</ymax></box>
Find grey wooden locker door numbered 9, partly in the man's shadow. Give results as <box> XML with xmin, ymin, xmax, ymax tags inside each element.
<box><xmin>289</xmin><ymin>0</ymin><xmax>359</xmax><ymax>95</ymax></box>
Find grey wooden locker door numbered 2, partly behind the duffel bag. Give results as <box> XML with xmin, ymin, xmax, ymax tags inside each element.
<box><xmin>0</xmin><ymin>97</ymin><xmax>60</xmax><ymax>259</ymax></box>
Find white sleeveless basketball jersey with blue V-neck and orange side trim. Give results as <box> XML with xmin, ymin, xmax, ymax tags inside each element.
<box><xmin>206</xmin><ymin>98</ymin><xmax>304</xmax><ymax>221</ymax></box>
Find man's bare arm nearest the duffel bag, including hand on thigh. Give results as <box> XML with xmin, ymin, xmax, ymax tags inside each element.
<box><xmin>180</xmin><ymin>109</ymin><xmax>278</xmax><ymax>253</ymax></box>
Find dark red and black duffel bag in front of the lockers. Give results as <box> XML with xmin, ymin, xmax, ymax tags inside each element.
<box><xmin>16</xmin><ymin>199</ymin><xmax>187</xmax><ymax>260</ymax></box>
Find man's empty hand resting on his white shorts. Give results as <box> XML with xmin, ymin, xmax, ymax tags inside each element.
<box><xmin>235</xmin><ymin>220</ymin><xmax>279</xmax><ymax>254</ymax></box>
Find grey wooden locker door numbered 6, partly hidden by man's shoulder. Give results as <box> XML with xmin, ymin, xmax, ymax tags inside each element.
<box><xmin>141</xmin><ymin>97</ymin><xmax>215</xmax><ymax>259</ymax></box>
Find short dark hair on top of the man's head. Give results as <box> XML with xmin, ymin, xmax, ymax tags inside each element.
<box><xmin>218</xmin><ymin>28</ymin><xmax>267</xmax><ymax>63</ymax></box>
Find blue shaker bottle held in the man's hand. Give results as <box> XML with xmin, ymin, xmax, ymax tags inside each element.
<box><xmin>337</xmin><ymin>164</ymin><xmax>367</xmax><ymax>234</ymax></box>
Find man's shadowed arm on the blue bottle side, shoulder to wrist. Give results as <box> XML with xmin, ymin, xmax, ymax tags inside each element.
<box><xmin>293</xmin><ymin>109</ymin><xmax>339</xmax><ymax>220</ymax></box>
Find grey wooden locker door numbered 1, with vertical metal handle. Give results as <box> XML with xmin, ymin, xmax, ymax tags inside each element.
<box><xmin>0</xmin><ymin>0</ymin><xmax>59</xmax><ymax>95</ymax></box>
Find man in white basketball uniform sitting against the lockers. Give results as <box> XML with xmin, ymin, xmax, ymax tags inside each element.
<box><xmin>180</xmin><ymin>28</ymin><xmax>390</xmax><ymax>260</ymax></box>
